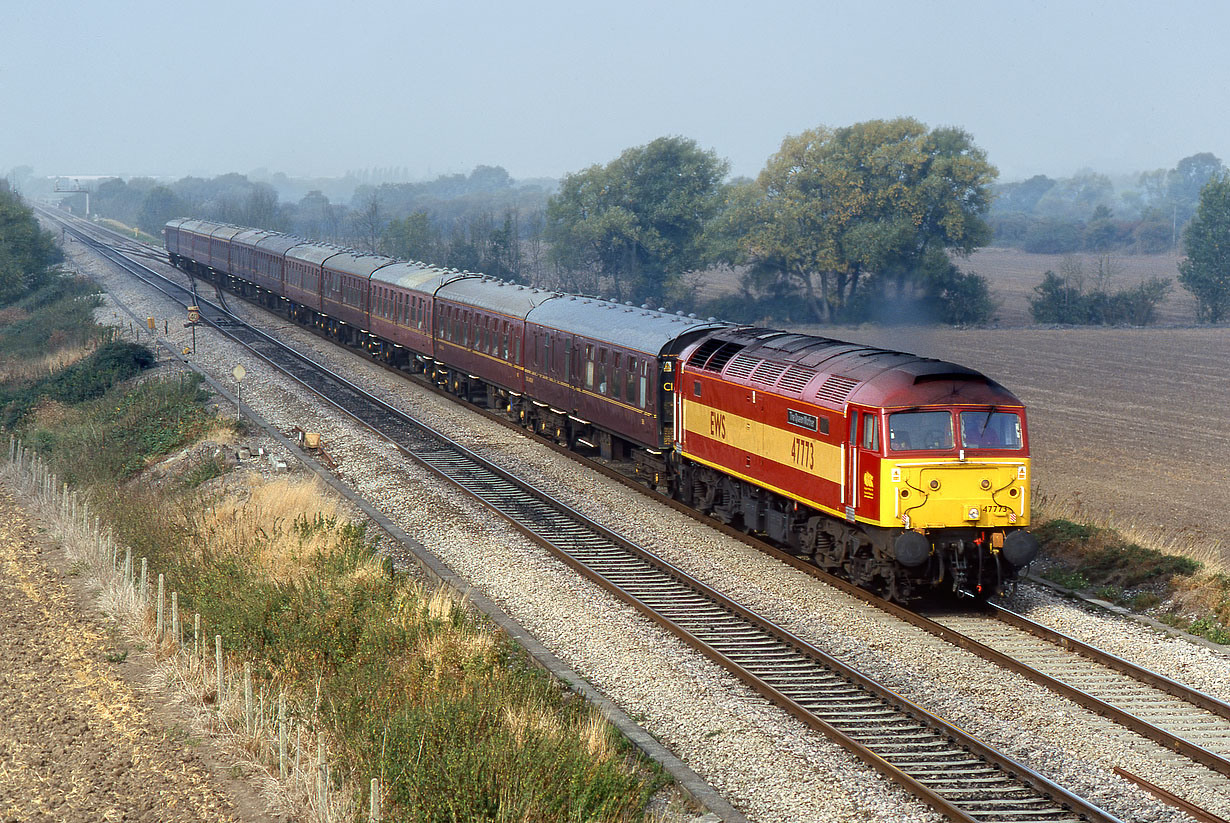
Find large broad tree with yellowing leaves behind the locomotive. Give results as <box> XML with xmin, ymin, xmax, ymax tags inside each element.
<box><xmin>743</xmin><ymin>118</ymin><xmax>996</xmax><ymax>322</ymax></box>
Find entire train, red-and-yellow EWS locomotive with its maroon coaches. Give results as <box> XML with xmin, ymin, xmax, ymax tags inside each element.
<box><xmin>164</xmin><ymin>219</ymin><xmax>1038</xmax><ymax>602</ymax></box>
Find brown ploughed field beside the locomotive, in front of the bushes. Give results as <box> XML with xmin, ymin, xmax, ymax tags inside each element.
<box><xmin>801</xmin><ymin>327</ymin><xmax>1230</xmax><ymax>565</ymax></box>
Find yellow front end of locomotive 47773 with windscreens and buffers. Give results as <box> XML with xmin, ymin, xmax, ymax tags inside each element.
<box><xmin>879</xmin><ymin>406</ymin><xmax>1038</xmax><ymax>593</ymax></box>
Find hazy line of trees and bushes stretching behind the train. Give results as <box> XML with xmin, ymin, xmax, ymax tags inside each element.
<box><xmin>43</xmin><ymin>118</ymin><xmax>1225</xmax><ymax>324</ymax></box>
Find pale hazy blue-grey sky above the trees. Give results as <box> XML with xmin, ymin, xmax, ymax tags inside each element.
<box><xmin>0</xmin><ymin>0</ymin><xmax>1230</xmax><ymax>181</ymax></box>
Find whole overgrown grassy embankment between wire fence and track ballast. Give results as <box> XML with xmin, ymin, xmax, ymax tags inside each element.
<box><xmin>0</xmin><ymin>283</ymin><xmax>667</xmax><ymax>821</ymax></box>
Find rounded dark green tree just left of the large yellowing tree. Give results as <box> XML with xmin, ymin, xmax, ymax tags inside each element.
<box><xmin>546</xmin><ymin>137</ymin><xmax>728</xmax><ymax>301</ymax></box>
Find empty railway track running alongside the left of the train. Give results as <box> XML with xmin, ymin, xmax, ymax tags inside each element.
<box><xmin>40</xmin><ymin>209</ymin><xmax>1131</xmax><ymax>823</ymax></box>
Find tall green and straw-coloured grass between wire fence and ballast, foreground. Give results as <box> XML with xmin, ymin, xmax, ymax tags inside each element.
<box><xmin>93</xmin><ymin>487</ymin><xmax>665</xmax><ymax>822</ymax></box>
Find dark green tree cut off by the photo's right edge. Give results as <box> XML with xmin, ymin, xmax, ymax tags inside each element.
<box><xmin>1178</xmin><ymin>172</ymin><xmax>1230</xmax><ymax>322</ymax></box>
